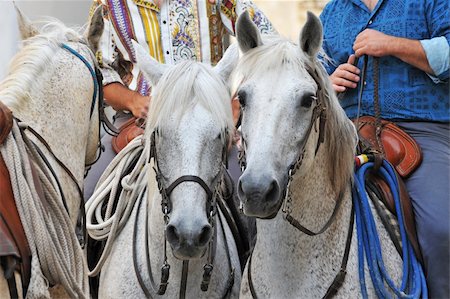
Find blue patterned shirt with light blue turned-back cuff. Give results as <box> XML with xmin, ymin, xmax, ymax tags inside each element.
<box><xmin>320</xmin><ymin>0</ymin><xmax>450</xmax><ymax>122</ymax></box>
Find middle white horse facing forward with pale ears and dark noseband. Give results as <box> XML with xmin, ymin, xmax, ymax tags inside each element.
<box><xmin>86</xmin><ymin>43</ymin><xmax>241</xmax><ymax>298</ymax></box>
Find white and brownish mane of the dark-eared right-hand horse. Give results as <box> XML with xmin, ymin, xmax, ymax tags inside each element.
<box><xmin>233</xmin><ymin>35</ymin><xmax>357</xmax><ymax>195</ymax></box>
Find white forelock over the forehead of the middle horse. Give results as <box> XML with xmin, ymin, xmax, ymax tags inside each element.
<box><xmin>147</xmin><ymin>61</ymin><xmax>233</xmax><ymax>136</ymax></box>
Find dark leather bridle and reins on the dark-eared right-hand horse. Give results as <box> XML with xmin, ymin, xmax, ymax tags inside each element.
<box><xmin>238</xmin><ymin>67</ymin><xmax>354</xmax><ymax>298</ymax></box>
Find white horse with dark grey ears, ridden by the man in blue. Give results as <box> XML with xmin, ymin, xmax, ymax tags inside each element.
<box><xmin>235</xmin><ymin>13</ymin><xmax>401</xmax><ymax>298</ymax></box>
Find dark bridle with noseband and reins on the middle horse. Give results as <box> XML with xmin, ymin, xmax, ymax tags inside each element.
<box><xmin>133</xmin><ymin>129</ymin><xmax>234</xmax><ymax>298</ymax></box>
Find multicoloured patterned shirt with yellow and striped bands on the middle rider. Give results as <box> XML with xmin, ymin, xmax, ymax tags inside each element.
<box><xmin>94</xmin><ymin>0</ymin><xmax>274</xmax><ymax>94</ymax></box>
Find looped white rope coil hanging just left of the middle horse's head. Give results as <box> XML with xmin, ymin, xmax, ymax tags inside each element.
<box><xmin>85</xmin><ymin>136</ymin><xmax>149</xmax><ymax>276</ymax></box>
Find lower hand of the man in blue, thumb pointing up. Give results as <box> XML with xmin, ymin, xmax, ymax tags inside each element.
<box><xmin>330</xmin><ymin>55</ymin><xmax>360</xmax><ymax>92</ymax></box>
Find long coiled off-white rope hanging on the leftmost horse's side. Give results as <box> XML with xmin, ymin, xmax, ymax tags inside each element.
<box><xmin>0</xmin><ymin>122</ymin><xmax>89</xmax><ymax>298</ymax></box>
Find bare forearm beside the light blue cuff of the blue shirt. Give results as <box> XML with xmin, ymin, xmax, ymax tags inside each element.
<box><xmin>388</xmin><ymin>36</ymin><xmax>434</xmax><ymax>75</ymax></box>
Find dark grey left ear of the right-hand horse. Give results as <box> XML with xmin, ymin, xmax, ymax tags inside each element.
<box><xmin>236</xmin><ymin>11</ymin><xmax>263</xmax><ymax>53</ymax></box>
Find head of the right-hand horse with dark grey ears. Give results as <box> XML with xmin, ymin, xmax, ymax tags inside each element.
<box><xmin>235</xmin><ymin>13</ymin><xmax>355</xmax><ymax>218</ymax></box>
